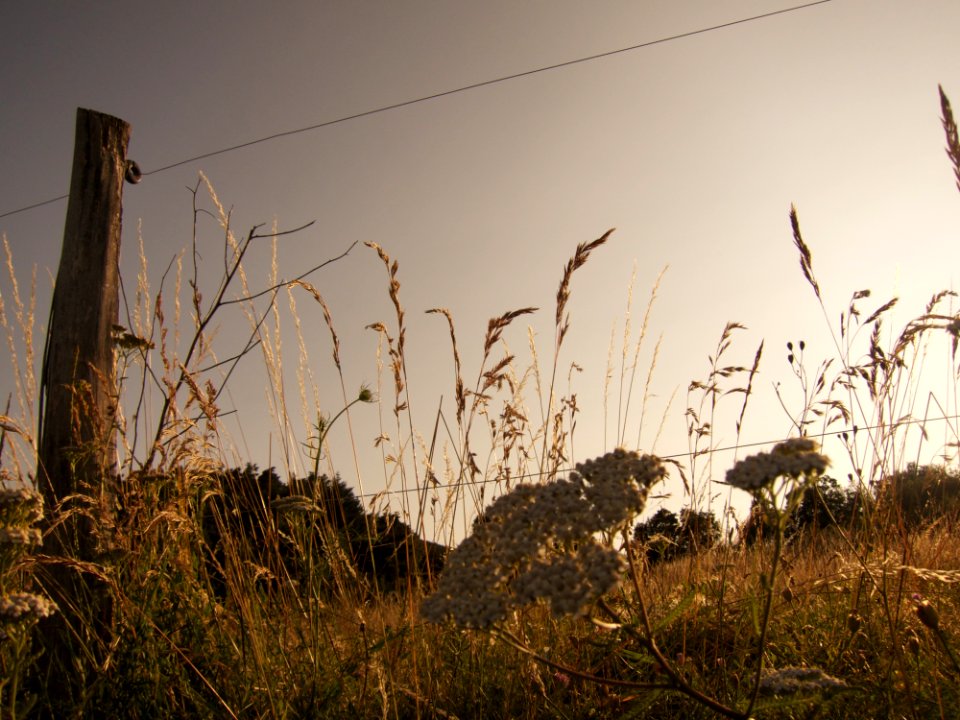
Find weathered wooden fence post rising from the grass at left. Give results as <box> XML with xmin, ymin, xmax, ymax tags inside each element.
<box><xmin>37</xmin><ymin>108</ymin><xmax>130</xmax><ymax>704</ymax></box>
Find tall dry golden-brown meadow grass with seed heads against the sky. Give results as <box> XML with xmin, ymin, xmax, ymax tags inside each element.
<box><xmin>0</xmin><ymin>87</ymin><xmax>960</xmax><ymax>719</ymax></box>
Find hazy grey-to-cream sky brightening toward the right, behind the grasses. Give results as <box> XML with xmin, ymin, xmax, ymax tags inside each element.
<box><xmin>0</xmin><ymin>0</ymin><xmax>960</xmax><ymax>536</ymax></box>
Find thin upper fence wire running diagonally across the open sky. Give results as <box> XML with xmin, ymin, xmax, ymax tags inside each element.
<box><xmin>0</xmin><ymin>0</ymin><xmax>833</xmax><ymax>218</ymax></box>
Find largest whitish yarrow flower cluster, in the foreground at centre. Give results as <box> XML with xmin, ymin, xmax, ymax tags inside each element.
<box><xmin>420</xmin><ymin>449</ymin><xmax>666</xmax><ymax>629</ymax></box>
